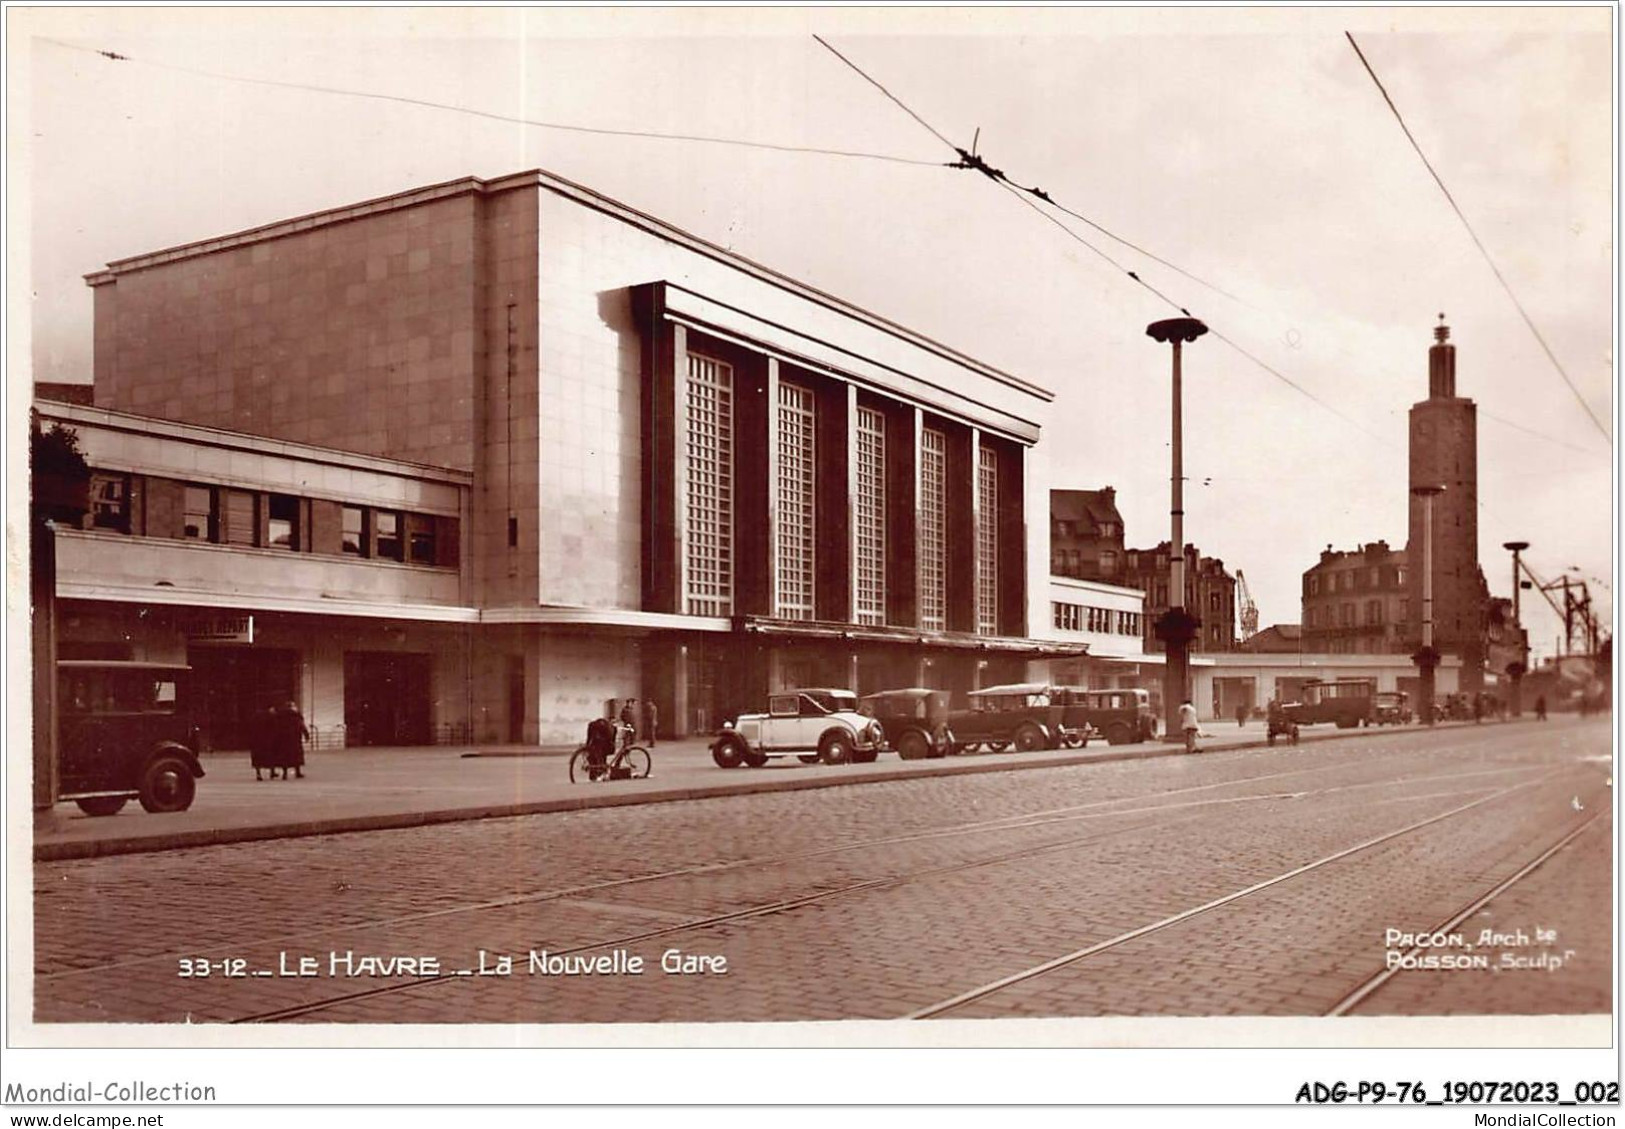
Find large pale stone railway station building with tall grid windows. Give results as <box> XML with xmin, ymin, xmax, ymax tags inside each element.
<box><xmin>37</xmin><ymin>172</ymin><xmax>1086</xmax><ymax>747</ymax></box>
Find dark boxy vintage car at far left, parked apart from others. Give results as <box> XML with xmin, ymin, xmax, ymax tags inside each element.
<box><xmin>57</xmin><ymin>660</ymin><xmax>203</xmax><ymax>815</ymax></box>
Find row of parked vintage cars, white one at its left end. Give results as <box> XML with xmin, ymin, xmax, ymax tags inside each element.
<box><xmin>712</xmin><ymin>682</ymin><xmax>1157</xmax><ymax>768</ymax></box>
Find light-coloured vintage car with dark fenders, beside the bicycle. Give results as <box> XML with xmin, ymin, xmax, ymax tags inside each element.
<box><xmin>712</xmin><ymin>689</ymin><xmax>886</xmax><ymax>768</ymax></box>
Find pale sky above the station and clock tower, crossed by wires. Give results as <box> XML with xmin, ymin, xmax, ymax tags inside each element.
<box><xmin>7</xmin><ymin>6</ymin><xmax>1617</xmax><ymax>655</ymax></box>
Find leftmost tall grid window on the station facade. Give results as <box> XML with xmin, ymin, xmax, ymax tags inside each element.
<box><xmin>683</xmin><ymin>354</ymin><xmax>733</xmax><ymax>616</ymax></box>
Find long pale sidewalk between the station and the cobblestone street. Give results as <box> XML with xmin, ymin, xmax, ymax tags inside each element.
<box><xmin>34</xmin><ymin>721</ymin><xmax>1534</xmax><ymax>861</ymax></box>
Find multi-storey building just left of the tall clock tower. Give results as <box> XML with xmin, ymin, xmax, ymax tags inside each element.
<box><xmin>1303</xmin><ymin>541</ymin><xmax>1415</xmax><ymax>655</ymax></box>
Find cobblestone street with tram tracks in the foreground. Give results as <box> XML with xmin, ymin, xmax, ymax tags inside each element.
<box><xmin>34</xmin><ymin>720</ymin><xmax>1614</xmax><ymax>1023</ymax></box>
